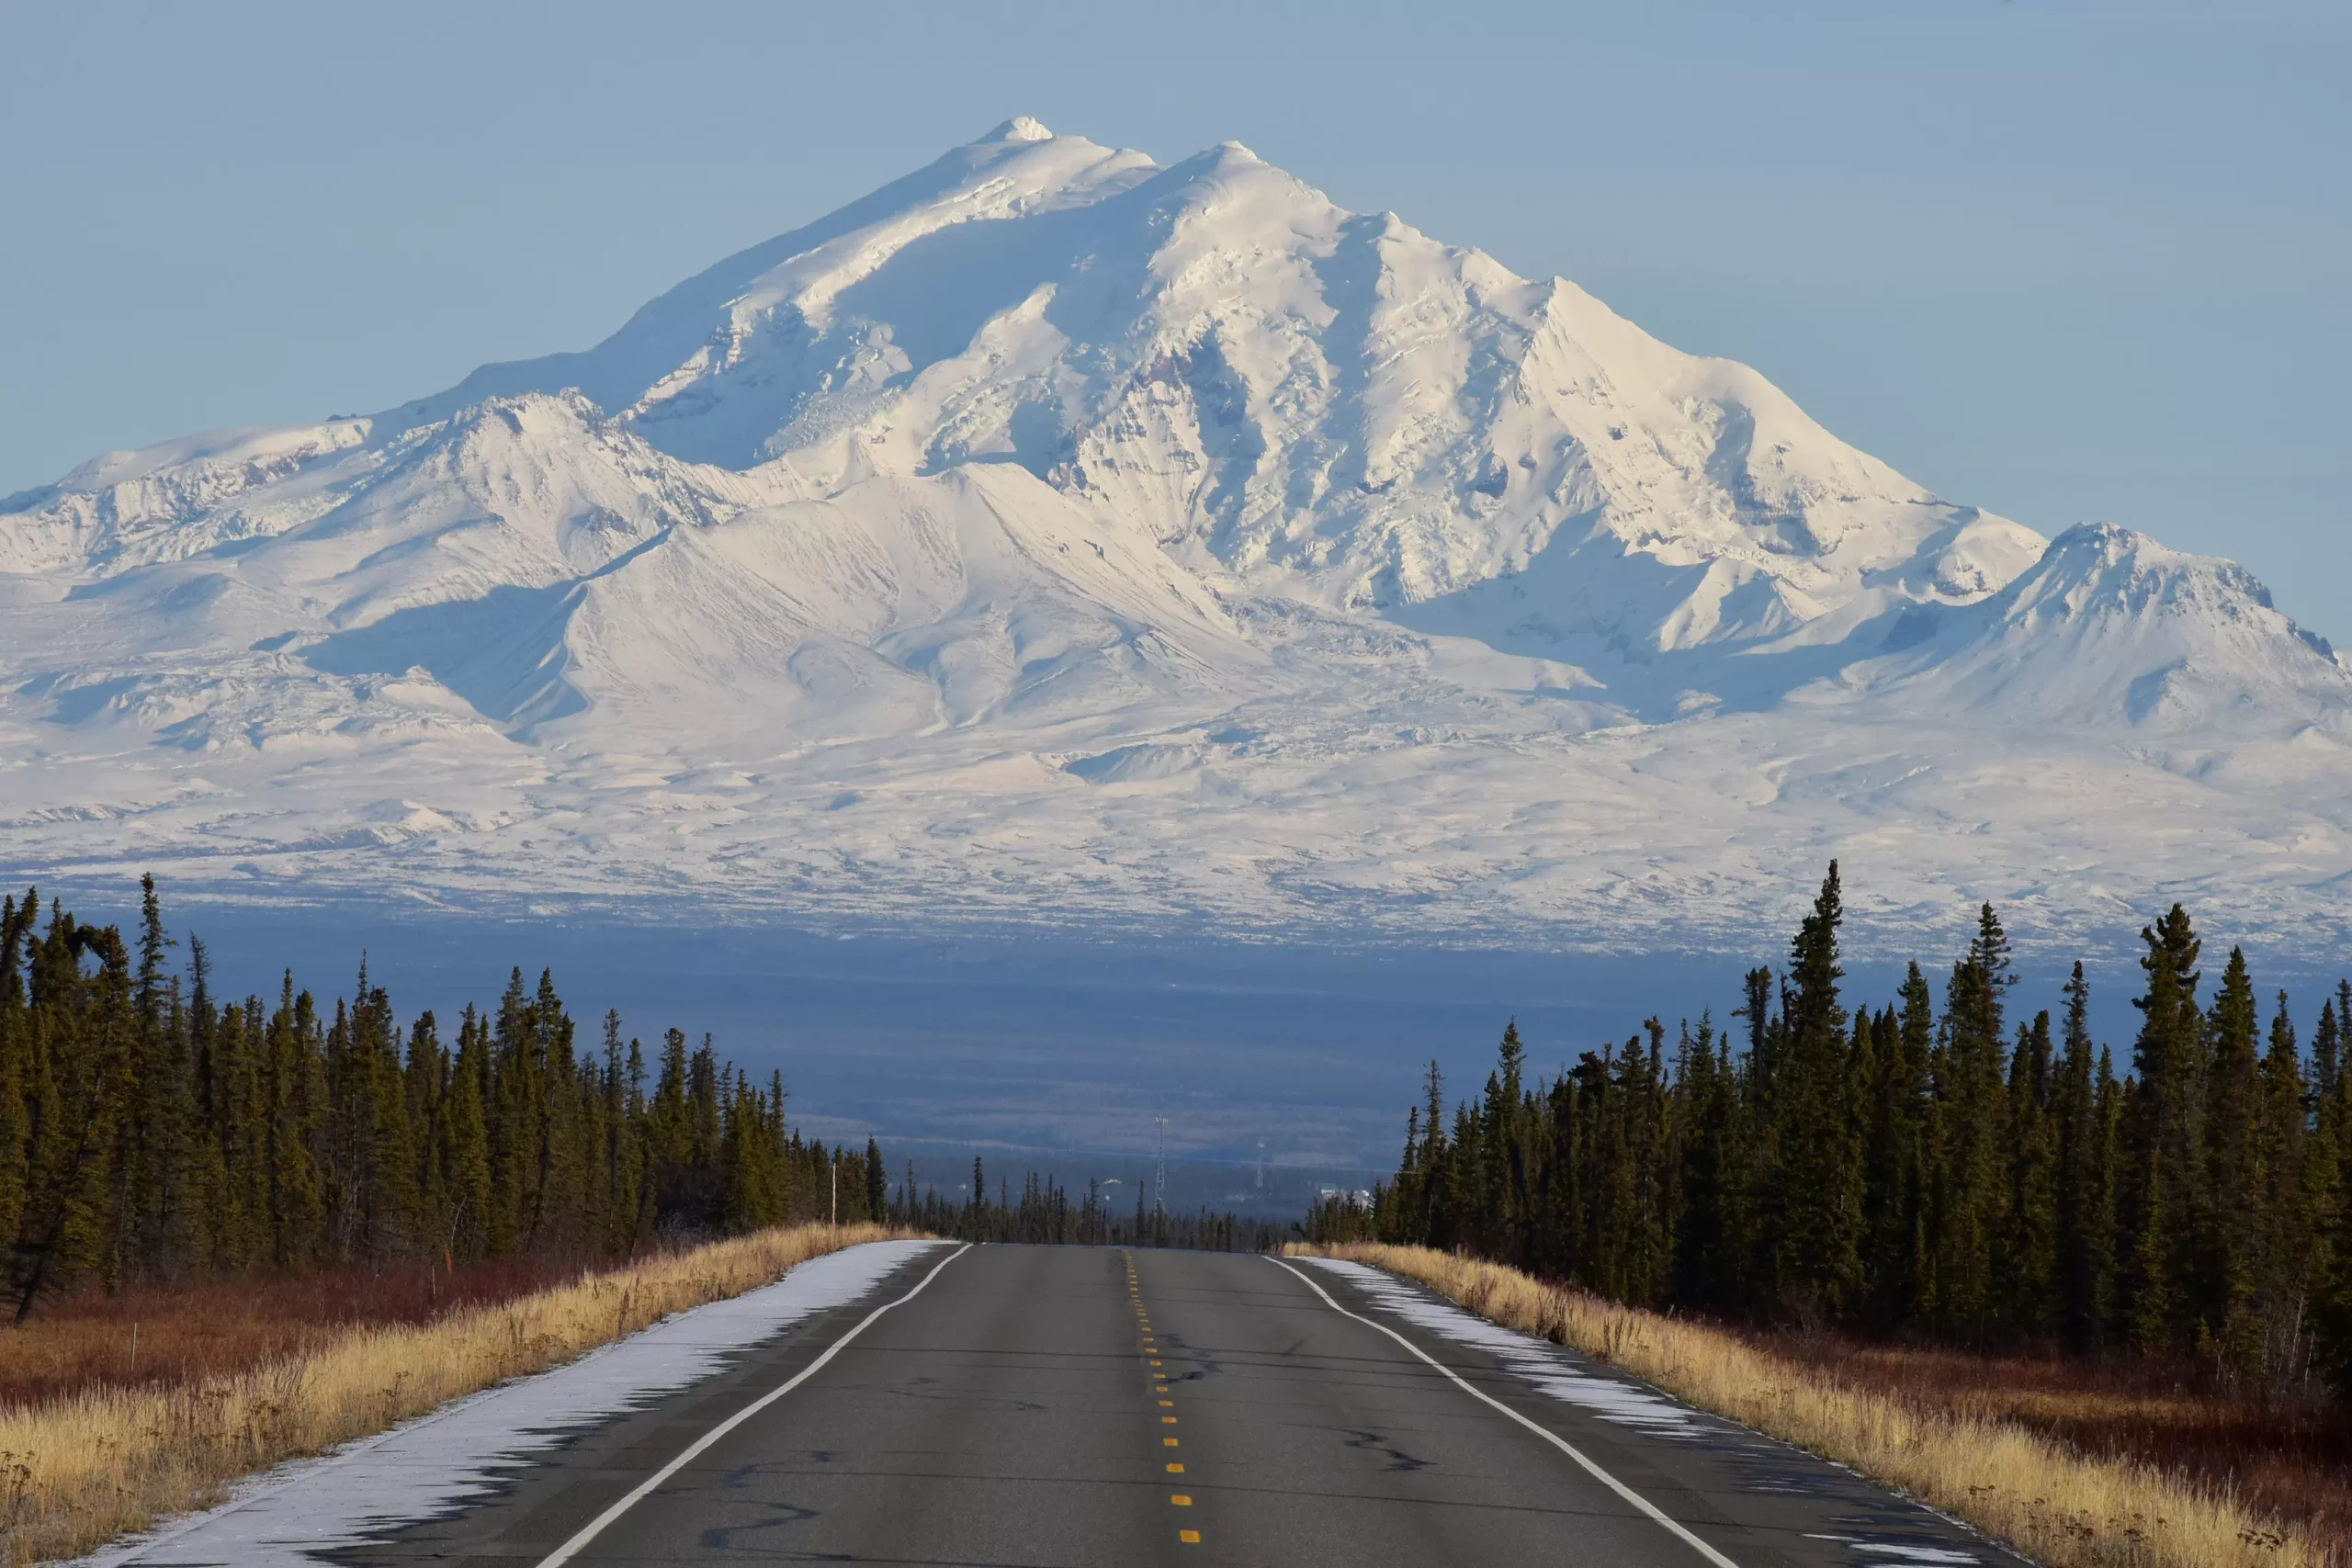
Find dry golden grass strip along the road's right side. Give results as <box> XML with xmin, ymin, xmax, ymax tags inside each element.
<box><xmin>1284</xmin><ymin>1244</ymin><xmax>2326</xmax><ymax>1568</ymax></box>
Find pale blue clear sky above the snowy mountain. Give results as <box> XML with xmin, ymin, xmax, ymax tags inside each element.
<box><xmin>0</xmin><ymin>0</ymin><xmax>2352</xmax><ymax>639</ymax></box>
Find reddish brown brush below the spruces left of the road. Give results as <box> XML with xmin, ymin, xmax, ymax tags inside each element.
<box><xmin>0</xmin><ymin>1258</ymin><xmax>581</xmax><ymax>1408</ymax></box>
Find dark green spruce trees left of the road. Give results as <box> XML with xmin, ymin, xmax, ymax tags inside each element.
<box><xmin>0</xmin><ymin>877</ymin><xmax>889</xmax><ymax>1321</ymax></box>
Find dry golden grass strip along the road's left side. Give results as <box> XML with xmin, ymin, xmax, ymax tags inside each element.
<box><xmin>0</xmin><ymin>1224</ymin><xmax>912</xmax><ymax>1563</ymax></box>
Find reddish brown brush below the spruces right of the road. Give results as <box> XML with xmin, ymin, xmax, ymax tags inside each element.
<box><xmin>1747</xmin><ymin>1333</ymin><xmax>2352</xmax><ymax>1565</ymax></box>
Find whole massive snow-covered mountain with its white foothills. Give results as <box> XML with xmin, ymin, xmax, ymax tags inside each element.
<box><xmin>0</xmin><ymin>120</ymin><xmax>2352</xmax><ymax>942</ymax></box>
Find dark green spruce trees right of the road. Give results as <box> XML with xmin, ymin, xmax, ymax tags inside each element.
<box><xmin>1363</xmin><ymin>863</ymin><xmax>2352</xmax><ymax>1394</ymax></box>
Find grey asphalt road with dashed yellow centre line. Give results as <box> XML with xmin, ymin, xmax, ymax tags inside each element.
<box><xmin>353</xmin><ymin>1246</ymin><xmax>2016</xmax><ymax>1568</ymax></box>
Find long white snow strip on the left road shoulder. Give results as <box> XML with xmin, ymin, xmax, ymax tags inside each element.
<box><xmin>73</xmin><ymin>1241</ymin><xmax>944</xmax><ymax>1568</ymax></box>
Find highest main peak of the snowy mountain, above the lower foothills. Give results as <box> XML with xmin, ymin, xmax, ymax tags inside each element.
<box><xmin>377</xmin><ymin>120</ymin><xmax>2041</xmax><ymax>651</ymax></box>
